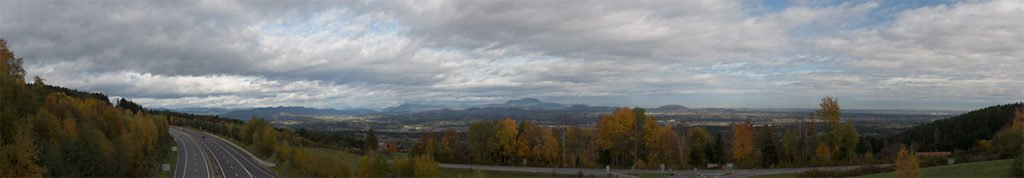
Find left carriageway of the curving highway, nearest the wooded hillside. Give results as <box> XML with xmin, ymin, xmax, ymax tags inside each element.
<box><xmin>168</xmin><ymin>129</ymin><xmax>211</xmax><ymax>177</ymax></box>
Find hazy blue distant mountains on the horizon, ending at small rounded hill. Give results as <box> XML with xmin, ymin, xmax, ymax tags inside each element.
<box><xmin>167</xmin><ymin>98</ymin><xmax>704</xmax><ymax>121</ymax></box>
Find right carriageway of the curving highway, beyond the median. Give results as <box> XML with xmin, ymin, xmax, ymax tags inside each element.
<box><xmin>178</xmin><ymin>129</ymin><xmax>274</xmax><ymax>177</ymax></box>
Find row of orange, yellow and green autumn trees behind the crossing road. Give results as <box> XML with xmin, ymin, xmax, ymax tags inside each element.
<box><xmin>412</xmin><ymin>97</ymin><xmax>880</xmax><ymax>169</ymax></box>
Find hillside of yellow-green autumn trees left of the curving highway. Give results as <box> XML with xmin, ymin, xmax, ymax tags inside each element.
<box><xmin>0</xmin><ymin>39</ymin><xmax>174</xmax><ymax>177</ymax></box>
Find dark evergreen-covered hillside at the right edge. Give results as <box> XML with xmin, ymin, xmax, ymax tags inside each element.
<box><xmin>895</xmin><ymin>103</ymin><xmax>1024</xmax><ymax>151</ymax></box>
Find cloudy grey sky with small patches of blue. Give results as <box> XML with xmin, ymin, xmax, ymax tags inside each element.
<box><xmin>0</xmin><ymin>0</ymin><xmax>1024</xmax><ymax>110</ymax></box>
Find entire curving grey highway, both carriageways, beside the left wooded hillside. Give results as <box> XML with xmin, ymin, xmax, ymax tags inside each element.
<box><xmin>169</xmin><ymin>127</ymin><xmax>274</xmax><ymax>177</ymax></box>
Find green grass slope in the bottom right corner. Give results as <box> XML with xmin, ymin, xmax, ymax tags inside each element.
<box><xmin>859</xmin><ymin>160</ymin><xmax>1013</xmax><ymax>177</ymax></box>
